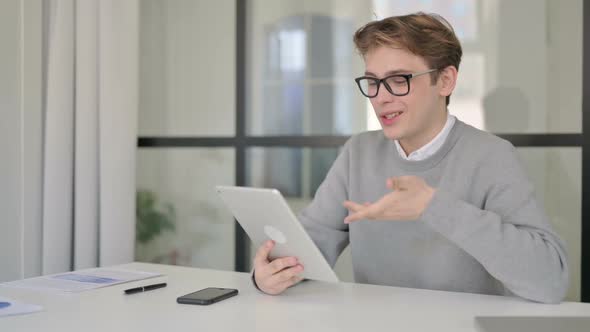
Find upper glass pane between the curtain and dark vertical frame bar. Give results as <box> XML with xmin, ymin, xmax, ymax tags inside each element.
<box><xmin>138</xmin><ymin>0</ymin><xmax>236</xmax><ymax>136</ymax></box>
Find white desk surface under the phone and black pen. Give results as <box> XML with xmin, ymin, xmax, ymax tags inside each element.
<box><xmin>0</xmin><ymin>263</ymin><xmax>590</xmax><ymax>332</ymax></box>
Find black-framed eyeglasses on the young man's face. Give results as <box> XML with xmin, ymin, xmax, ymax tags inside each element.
<box><xmin>354</xmin><ymin>69</ymin><xmax>438</xmax><ymax>98</ymax></box>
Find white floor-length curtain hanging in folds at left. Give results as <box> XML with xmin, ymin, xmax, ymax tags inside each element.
<box><xmin>42</xmin><ymin>0</ymin><xmax>139</xmax><ymax>274</ymax></box>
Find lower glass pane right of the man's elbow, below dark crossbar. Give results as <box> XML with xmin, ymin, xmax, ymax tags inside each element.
<box><xmin>518</xmin><ymin>148</ymin><xmax>582</xmax><ymax>301</ymax></box>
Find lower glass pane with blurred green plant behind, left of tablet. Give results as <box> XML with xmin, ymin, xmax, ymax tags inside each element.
<box><xmin>136</xmin><ymin>148</ymin><xmax>235</xmax><ymax>270</ymax></box>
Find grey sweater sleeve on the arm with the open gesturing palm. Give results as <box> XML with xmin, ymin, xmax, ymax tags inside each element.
<box><xmin>421</xmin><ymin>143</ymin><xmax>569</xmax><ymax>303</ymax></box>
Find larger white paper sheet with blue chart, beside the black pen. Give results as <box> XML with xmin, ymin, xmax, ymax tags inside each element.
<box><xmin>0</xmin><ymin>268</ymin><xmax>162</xmax><ymax>292</ymax></box>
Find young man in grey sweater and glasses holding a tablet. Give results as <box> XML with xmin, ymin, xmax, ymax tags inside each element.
<box><xmin>254</xmin><ymin>13</ymin><xmax>568</xmax><ymax>303</ymax></box>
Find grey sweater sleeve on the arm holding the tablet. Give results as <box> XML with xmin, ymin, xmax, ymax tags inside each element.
<box><xmin>299</xmin><ymin>138</ymin><xmax>354</xmax><ymax>267</ymax></box>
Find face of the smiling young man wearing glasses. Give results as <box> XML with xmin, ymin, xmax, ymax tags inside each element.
<box><xmin>364</xmin><ymin>47</ymin><xmax>446</xmax><ymax>149</ymax></box>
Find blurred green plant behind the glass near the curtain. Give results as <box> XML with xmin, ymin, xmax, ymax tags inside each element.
<box><xmin>135</xmin><ymin>190</ymin><xmax>176</xmax><ymax>244</ymax></box>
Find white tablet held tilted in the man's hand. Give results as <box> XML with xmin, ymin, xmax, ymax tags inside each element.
<box><xmin>215</xmin><ymin>186</ymin><xmax>338</xmax><ymax>282</ymax></box>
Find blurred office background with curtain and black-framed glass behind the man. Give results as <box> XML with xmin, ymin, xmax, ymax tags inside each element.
<box><xmin>0</xmin><ymin>0</ymin><xmax>590</xmax><ymax>301</ymax></box>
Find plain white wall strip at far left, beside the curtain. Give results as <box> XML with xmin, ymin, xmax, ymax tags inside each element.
<box><xmin>0</xmin><ymin>0</ymin><xmax>42</xmax><ymax>282</ymax></box>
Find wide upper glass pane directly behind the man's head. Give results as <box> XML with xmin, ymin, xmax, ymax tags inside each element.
<box><xmin>246</xmin><ymin>0</ymin><xmax>583</xmax><ymax>135</ymax></box>
